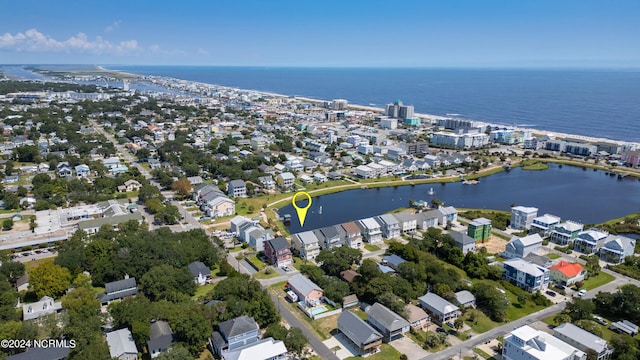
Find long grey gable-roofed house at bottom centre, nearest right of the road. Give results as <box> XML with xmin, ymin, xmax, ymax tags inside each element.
<box><xmin>338</xmin><ymin>311</ymin><xmax>382</xmax><ymax>356</ymax></box>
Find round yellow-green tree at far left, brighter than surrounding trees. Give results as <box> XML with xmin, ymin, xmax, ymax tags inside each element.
<box><xmin>29</xmin><ymin>261</ymin><xmax>71</xmax><ymax>298</ymax></box>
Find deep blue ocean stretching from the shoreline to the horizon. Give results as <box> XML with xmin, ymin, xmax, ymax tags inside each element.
<box><xmin>119</xmin><ymin>66</ymin><xmax>640</xmax><ymax>142</ymax></box>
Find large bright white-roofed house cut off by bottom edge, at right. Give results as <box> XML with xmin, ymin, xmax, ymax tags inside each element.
<box><xmin>502</xmin><ymin>325</ymin><xmax>587</xmax><ymax>360</ymax></box>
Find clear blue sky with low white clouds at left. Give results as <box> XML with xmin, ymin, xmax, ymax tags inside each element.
<box><xmin>0</xmin><ymin>0</ymin><xmax>640</xmax><ymax>67</ymax></box>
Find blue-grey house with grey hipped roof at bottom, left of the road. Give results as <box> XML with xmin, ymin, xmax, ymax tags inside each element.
<box><xmin>209</xmin><ymin>315</ymin><xmax>260</xmax><ymax>357</ymax></box>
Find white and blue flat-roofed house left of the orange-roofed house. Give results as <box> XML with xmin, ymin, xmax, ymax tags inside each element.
<box><xmin>502</xmin><ymin>258</ymin><xmax>551</xmax><ymax>292</ymax></box>
